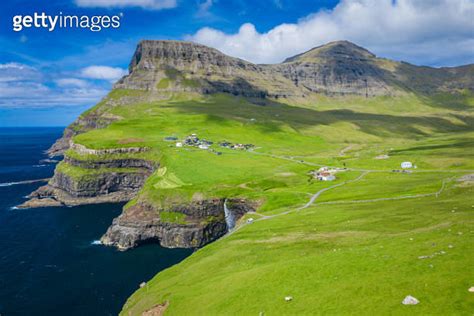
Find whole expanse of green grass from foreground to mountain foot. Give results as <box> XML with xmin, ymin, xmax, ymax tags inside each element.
<box><xmin>60</xmin><ymin>90</ymin><xmax>474</xmax><ymax>315</ymax></box>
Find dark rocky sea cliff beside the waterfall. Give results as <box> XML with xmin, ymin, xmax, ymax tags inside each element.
<box><xmin>101</xmin><ymin>199</ymin><xmax>254</xmax><ymax>250</ymax></box>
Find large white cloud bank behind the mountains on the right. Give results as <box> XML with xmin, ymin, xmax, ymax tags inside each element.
<box><xmin>187</xmin><ymin>0</ymin><xmax>474</xmax><ymax>65</ymax></box>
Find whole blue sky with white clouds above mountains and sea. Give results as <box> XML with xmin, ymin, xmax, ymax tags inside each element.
<box><xmin>0</xmin><ymin>0</ymin><xmax>474</xmax><ymax>127</ymax></box>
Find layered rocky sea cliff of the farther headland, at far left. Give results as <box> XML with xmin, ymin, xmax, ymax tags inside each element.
<box><xmin>19</xmin><ymin>143</ymin><xmax>159</xmax><ymax>208</ymax></box>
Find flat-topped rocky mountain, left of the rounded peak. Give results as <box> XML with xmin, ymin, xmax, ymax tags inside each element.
<box><xmin>115</xmin><ymin>41</ymin><xmax>303</xmax><ymax>98</ymax></box>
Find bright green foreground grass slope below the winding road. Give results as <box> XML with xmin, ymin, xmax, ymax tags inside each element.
<box><xmin>122</xmin><ymin>183</ymin><xmax>474</xmax><ymax>315</ymax></box>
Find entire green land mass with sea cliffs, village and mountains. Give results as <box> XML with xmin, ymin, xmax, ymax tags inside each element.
<box><xmin>20</xmin><ymin>41</ymin><xmax>474</xmax><ymax>315</ymax></box>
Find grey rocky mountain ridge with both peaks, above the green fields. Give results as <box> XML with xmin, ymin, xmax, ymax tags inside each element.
<box><xmin>115</xmin><ymin>41</ymin><xmax>474</xmax><ymax>98</ymax></box>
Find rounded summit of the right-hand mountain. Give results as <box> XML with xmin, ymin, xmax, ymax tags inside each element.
<box><xmin>284</xmin><ymin>40</ymin><xmax>375</xmax><ymax>63</ymax></box>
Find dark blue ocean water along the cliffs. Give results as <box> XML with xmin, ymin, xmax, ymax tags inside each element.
<box><xmin>0</xmin><ymin>128</ymin><xmax>191</xmax><ymax>316</ymax></box>
